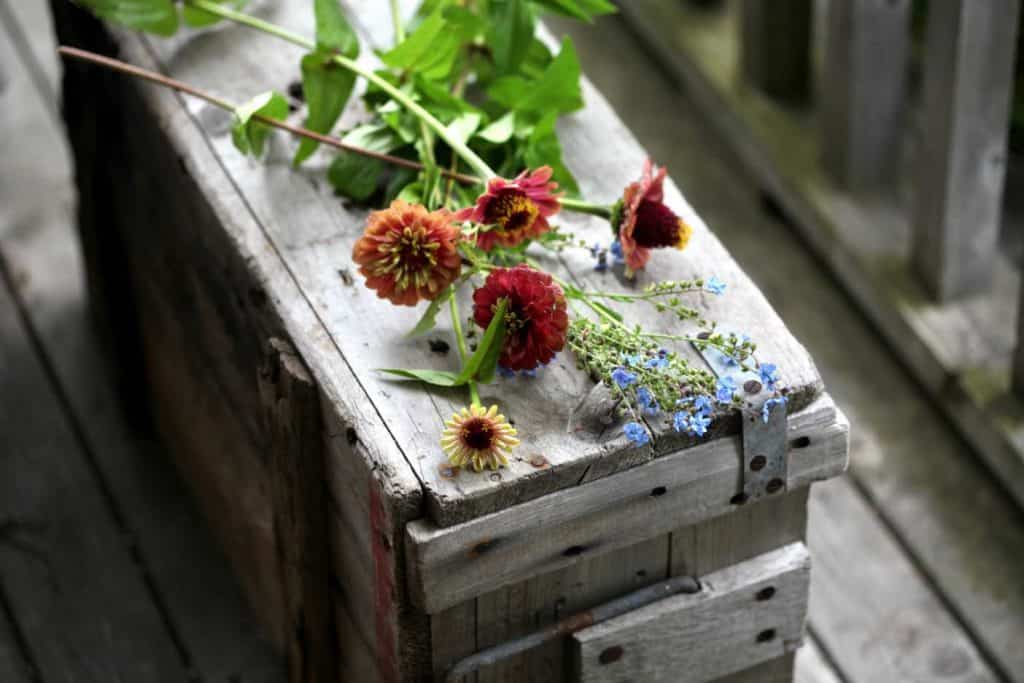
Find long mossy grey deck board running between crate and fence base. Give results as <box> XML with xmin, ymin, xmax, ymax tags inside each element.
<box><xmin>558</xmin><ymin>9</ymin><xmax>1024</xmax><ymax>681</ymax></box>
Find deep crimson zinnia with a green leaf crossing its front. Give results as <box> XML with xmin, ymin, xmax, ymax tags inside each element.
<box><xmin>473</xmin><ymin>264</ymin><xmax>569</xmax><ymax>370</ymax></box>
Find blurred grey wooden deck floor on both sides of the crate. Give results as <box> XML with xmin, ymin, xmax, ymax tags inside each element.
<box><xmin>0</xmin><ymin>0</ymin><xmax>1024</xmax><ymax>683</ymax></box>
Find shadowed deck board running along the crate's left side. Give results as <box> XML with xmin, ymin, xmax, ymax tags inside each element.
<box><xmin>0</xmin><ymin>3</ymin><xmax>284</xmax><ymax>683</ymax></box>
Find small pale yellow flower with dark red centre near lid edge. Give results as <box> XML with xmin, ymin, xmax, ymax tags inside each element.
<box><xmin>441</xmin><ymin>405</ymin><xmax>519</xmax><ymax>472</ymax></box>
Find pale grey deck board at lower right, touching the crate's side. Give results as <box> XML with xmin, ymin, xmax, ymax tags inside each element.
<box><xmin>809</xmin><ymin>479</ymin><xmax>998</xmax><ymax>682</ymax></box>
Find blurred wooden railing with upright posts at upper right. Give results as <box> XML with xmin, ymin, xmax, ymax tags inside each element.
<box><xmin>620</xmin><ymin>0</ymin><xmax>1024</xmax><ymax>503</ymax></box>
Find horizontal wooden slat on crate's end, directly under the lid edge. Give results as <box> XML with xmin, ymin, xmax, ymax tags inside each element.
<box><xmin>407</xmin><ymin>399</ymin><xmax>848</xmax><ymax>613</ymax></box>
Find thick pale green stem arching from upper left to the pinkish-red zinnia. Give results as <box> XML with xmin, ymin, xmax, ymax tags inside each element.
<box><xmin>191</xmin><ymin>0</ymin><xmax>499</xmax><ymax>183</ymax></box>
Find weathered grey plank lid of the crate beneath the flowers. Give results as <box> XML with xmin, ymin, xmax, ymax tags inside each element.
<box><xmin>118</xmin><ymin>0</ymin><xmax>834</xmax><ymax>526</ymax></box>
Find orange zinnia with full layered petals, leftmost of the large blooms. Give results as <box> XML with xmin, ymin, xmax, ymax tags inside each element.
<box><xmin>352</xmin><ymin>200</ymin><xmax>462</xmax><ymax>306</ymax></box>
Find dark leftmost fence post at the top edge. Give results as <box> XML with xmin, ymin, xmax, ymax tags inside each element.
<box><xmin>740</xmin><ymin>0</ymin><xmax>814</xmax><ymax>100</ymax></box>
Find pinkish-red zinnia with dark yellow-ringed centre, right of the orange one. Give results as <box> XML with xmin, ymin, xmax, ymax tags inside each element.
<box><xmin>455</xmin><ymin>166</ymin><xmax>561</xmax><ymax>251</ymax></box>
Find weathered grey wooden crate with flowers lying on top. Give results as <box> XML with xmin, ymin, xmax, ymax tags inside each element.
<box><xmin>53</xmin><ymin>0</ymin><xmax>848</xmax><ymax>681</ymax></box>
